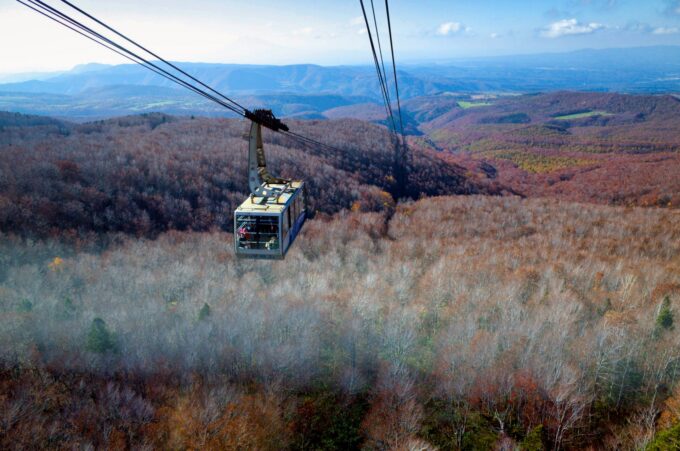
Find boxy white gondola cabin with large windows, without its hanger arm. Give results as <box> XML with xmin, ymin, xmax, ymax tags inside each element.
<box><xmin>234</xmin><ymin>181</ymin><xmax>307</xmax><ymax>260</ymax></box>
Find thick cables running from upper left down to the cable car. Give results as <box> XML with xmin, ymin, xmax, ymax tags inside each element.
<box><xmin>17</xmin><ymin>0</ymin><xmax>343</xmax><ymax>153</ymax></box>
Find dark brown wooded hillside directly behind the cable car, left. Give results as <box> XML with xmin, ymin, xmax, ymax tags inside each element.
<box><xmin>0</xmin><ymin>113</ymin><xmax>502</xmax><ymax>237</ymax></box>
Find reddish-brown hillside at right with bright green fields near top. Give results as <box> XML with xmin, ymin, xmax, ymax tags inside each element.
<box><xmin>405</xmin><ymin>92</ymin><xmax>680</xmax><ymax>207</ymax></box>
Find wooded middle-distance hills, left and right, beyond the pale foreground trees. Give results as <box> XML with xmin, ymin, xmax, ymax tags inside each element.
<box><xmin>0</xmin><ymin>92</ymin><xmax>680</xmax><ymax>244</ymax></box>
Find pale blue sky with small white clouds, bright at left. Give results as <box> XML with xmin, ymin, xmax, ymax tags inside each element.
<box><xmin>0</xmin><ymin>0</ymin><xmax>680</xmax><ymax>74</ymax></box>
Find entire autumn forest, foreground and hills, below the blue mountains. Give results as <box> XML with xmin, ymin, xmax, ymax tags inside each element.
<box><xmin>0</xmin><ymin>98</ymin><xmax>680</xmax><ymax>450</ymax></box>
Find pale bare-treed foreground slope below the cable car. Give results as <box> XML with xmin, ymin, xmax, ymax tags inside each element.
<box><xmin>0</xmin><ymin>196</ymin><xmax>680</xmax><ymax>450</ymax></box>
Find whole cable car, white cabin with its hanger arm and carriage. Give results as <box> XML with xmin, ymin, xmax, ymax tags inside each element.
<box><xmin>234</xmin><ymin>110</ymin><xmax>307</xmax><ymax>260</ymax></box>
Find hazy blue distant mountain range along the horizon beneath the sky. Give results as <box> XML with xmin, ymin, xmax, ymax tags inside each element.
<box><xmin>0</xmin><ymin>46</ymin><xmax>680</xmax><ymax>120</ymax></box>
